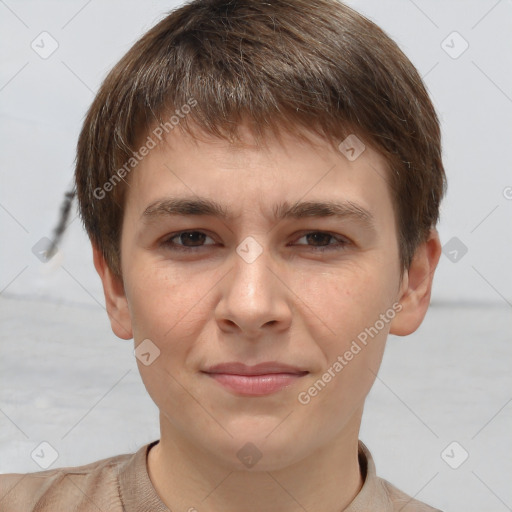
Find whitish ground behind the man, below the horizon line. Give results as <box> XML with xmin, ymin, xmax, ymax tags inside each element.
<box><xmin>0</xmin><ymin>297</ymin><xmax>512</xmax><ymax>512</ymax></box>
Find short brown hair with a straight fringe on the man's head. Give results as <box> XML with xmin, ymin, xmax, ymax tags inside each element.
<box><xmin>75</xmin><ymin>0</ymin><xmax>446</xmax><ymax>276</ymax></box>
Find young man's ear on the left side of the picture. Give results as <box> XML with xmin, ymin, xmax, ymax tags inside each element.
<box><xmin>92</xmin><ymin>244</ymin><xmax>133</xmax><ymax>340</ymax></box>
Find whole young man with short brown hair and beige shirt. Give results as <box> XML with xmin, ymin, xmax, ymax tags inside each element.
<box><xmin>0</xmin><ymin>0</ymin><xmax>445</xmax><ymax>512</ymax></box>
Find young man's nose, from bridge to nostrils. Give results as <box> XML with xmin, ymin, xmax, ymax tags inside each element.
<box><xmin>215</xmin><ymin>240</ymin><xmax>293</xmax><ymax>338</ymax></box>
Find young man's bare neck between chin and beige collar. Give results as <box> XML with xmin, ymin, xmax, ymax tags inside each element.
<box><xmin>148</xmin><ymin>414</ymin><xmax>363</xmax><ymax>512</ymax></box>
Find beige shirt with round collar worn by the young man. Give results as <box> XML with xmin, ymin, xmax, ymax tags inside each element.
<box><xmin>0</xmin><ymin>441</ymin><xmax>440</xmax><ymax>512</ymax></box>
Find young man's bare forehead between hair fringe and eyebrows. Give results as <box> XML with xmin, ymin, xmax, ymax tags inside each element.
<box><xmin>126</xmin><ymin>123</ymin><xmax>393</xmax><ymax>229</ymax></box>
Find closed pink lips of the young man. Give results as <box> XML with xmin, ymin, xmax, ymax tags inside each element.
<box><xmin>203</xmin><ymin>362</ymin><xmax>309</xmax><ymax>396</ymax></box>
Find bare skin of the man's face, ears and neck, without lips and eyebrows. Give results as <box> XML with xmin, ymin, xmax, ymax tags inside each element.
<box><xmin>93</xmin><ymin>125</ymin><xmax>441</xmax><ymax>512</ymax></box>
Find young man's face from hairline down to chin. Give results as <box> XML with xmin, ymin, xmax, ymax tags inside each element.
<box><xmin>95</xmin><ymin>125</ymin><xmax>436</xmax><ymax>469</ymax></box>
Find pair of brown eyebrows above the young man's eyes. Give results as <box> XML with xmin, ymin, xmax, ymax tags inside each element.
<box><xmin>141</xmin><ymin>197</ymin><xmax>375</xmax><ymax>229</ymax></box>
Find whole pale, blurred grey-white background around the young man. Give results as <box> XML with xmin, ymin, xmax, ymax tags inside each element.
<box><xmin>0</xmin><ymin>0</ymin><xmax>512</xmax><ymax>512</ymax></box>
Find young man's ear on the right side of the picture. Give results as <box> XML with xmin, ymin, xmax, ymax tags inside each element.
<box><xmin>389</xmin><ymin>229</ymin><xmax>442</xmax><ymax>336</ymax></box>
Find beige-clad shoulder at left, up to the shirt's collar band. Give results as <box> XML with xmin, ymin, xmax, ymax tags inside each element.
<box><xmin>0</xmin><ymin>454</ymin><xmax>134</xmax><ymax>512</ymax></box>
